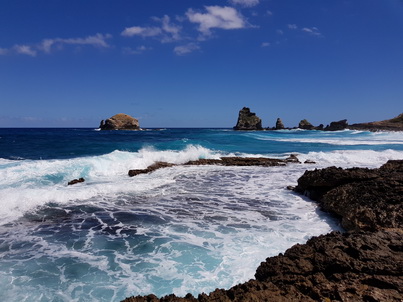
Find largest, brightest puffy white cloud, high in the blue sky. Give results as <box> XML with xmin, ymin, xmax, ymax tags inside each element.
<box><xmin>186</xmin><ymin>6</ymin><xmax>247</xmax><ymax>36</ymax></box>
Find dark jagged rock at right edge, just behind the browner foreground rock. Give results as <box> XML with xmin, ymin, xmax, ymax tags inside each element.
<box><xmin>295</xmin><ymin>160</ymin><xmax>403</xmax><ymax>231</ymax></box>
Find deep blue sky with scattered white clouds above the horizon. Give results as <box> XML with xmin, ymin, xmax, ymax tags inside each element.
<box><xmin>0</xmin><ymin>0</ymin><xmax>403</xmax><ymax>128</ymax></box>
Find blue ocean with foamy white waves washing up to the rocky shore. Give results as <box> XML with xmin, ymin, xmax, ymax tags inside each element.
<box><xmin>0</xmin><ymin>128</ymin><xmax>403</xmax><ymax>302</ymax></box>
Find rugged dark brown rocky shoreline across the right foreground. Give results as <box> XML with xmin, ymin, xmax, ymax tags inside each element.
<box><xmin>124</xmin><ymin>160</ymin><xmax>403</xmax><ymax>302</ymax></box>
